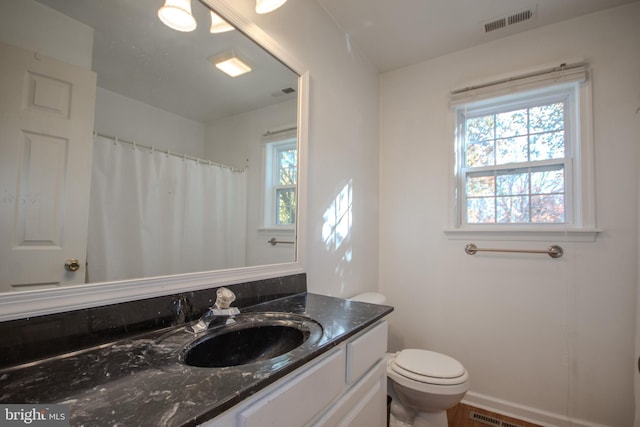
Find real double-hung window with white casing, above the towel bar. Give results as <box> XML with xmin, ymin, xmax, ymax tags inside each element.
<box><xmin>452</xmin><ymin>67</ymin><xmax>592</xmax><ymax>237</ymax></box>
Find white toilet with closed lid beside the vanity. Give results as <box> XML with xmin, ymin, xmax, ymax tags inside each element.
<box><xmin>351</xmin><ymin>292</ymin><xmax>469</xmax><ymax>427</ymax></box>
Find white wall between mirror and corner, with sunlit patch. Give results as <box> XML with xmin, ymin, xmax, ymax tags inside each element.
<box><xmin>228</xmin><ymin>1</ymin><xmax>379</xmax><ymax>296</ymax></box>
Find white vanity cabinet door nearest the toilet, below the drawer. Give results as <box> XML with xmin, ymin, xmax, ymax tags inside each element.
<box><xmin>312</xmin><ymin>360</ymin><xmax>387</xmax><ymax>427</ymax></box>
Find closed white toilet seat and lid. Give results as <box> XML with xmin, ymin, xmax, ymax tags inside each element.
<box><xmin>390</xmin><ymin>349</ymin><xmax>469</xmax><ymax>385</ymax></box>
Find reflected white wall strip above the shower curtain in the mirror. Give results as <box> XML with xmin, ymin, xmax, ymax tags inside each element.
<box><xmin>94</xmin><ymin>88</ymin><xmax>205</xmax><ymax>160</ymax></box>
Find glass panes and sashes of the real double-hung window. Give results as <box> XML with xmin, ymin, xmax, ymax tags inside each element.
<box><xmin>459</xmin><ymin>90</ymin><xmax>574</xmax><ymax>224</ymax></box>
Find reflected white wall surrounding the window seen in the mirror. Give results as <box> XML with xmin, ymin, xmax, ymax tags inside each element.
<box><xmin>205</xmin><ymin>99</ymin><xmax>298</xmax><ymax>266</ymax></box>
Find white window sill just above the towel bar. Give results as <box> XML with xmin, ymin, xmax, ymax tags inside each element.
<box><xmin>443</xmin><ymin>225</ymin><xmax>602</xmax><ymax>242</ymax></box>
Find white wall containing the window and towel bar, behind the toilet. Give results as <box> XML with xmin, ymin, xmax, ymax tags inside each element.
<box><xmin>379</xmin><ymin>3</ymin><xmax>640</xmax><ymax>427</ymax></box>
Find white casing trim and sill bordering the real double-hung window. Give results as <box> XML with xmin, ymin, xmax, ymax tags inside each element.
<box><xmin>443</xmin><ymin>68</ymin><xmax>601</xmax><ymax>241</ymax></box>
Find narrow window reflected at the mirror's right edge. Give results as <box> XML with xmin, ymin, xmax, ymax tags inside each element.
<box><xmin>264</xmin><ymin>137</ymin><xmax>298</xmax><ymax>228</ymax></box>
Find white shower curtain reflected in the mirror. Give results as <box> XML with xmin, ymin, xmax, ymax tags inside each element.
<box><xmin>87</xmin><ymin>136</ymin><xmax>246</xmax><ymax>282</ymax></box>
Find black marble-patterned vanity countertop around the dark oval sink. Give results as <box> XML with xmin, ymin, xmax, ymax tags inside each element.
<box><xmin>0</xmin><ymin>293</ymin><xmax>393</xmax><ymax>426</ymax></box>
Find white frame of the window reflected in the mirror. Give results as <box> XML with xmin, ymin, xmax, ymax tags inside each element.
<box><xmin>262</xmin><ymin>134</ymin><xmax>299</xmax><ymax>230</ymax></box>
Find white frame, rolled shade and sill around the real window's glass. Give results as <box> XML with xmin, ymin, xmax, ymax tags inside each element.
<box><xmin>444</xmin><ymin>65</ymin><xmax>599</xmax><ymax>241</ymax></box>
